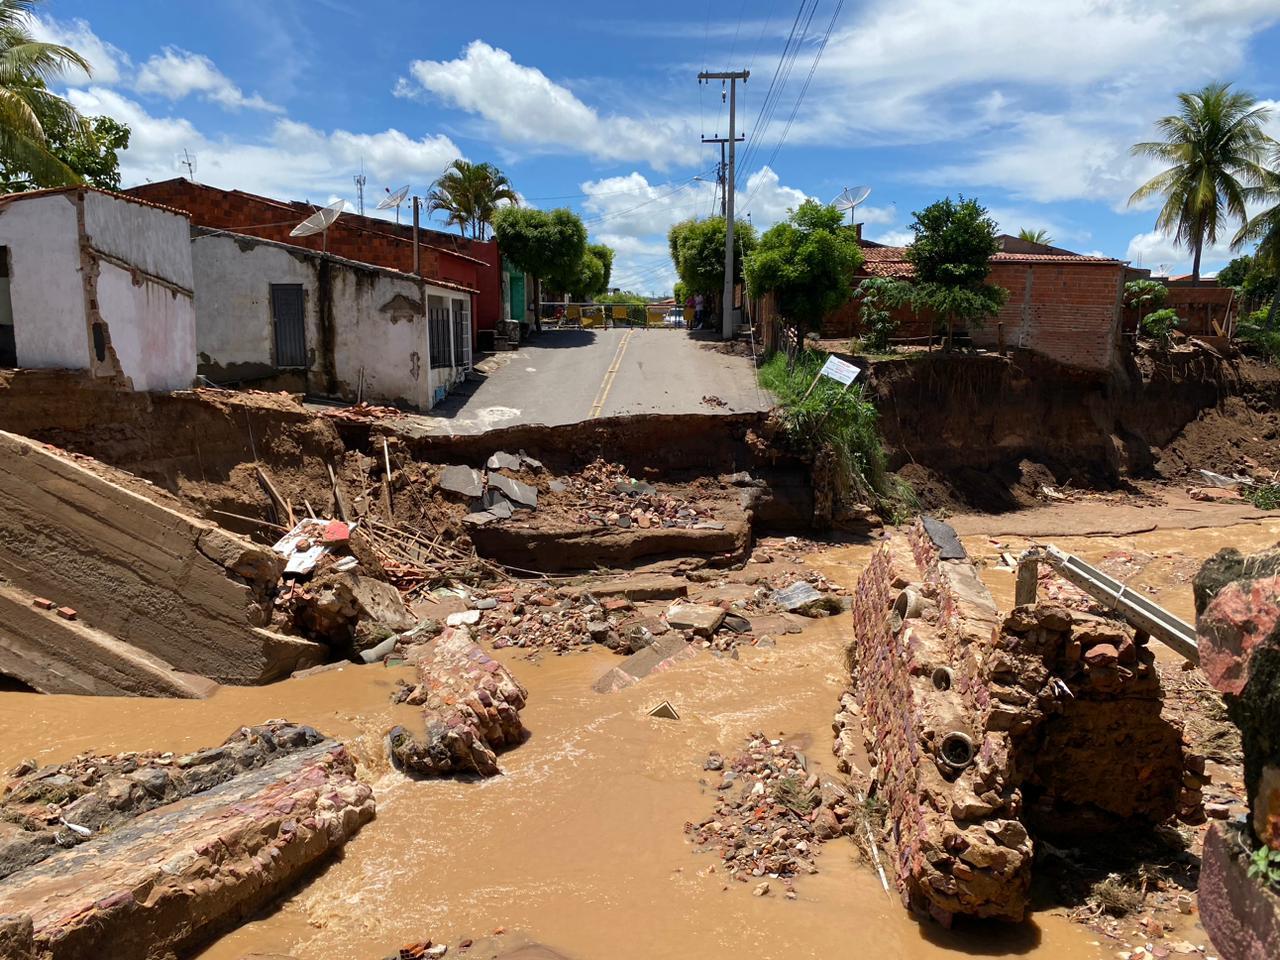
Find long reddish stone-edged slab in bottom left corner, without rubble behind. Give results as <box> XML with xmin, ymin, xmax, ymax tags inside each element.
<box><xmin>0</xmin><ymin>724</ymin><xmax>374</xmax><ymax>960</ymax></box>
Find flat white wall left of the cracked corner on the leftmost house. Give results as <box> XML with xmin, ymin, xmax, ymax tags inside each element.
<box><xmin>0</xmin><ymin>193</ymin><xmax>91</xmax><ymax>370</ymax></box>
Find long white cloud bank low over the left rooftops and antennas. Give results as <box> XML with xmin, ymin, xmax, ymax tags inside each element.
<box><xmin>68</xmin><ymin>87</ymin><xmax>462</xmax><ymax>200</ymax></box>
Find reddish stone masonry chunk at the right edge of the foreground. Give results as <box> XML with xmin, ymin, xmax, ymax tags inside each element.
<box><xmin>1196</xmin><ymin>544</ymin><xmax>1280</xmax><ymax>960</ymax></box>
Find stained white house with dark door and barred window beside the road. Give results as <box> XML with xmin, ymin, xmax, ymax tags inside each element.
<box><xmin>191</xmin><ymin>235</ymin><xmax>474</xmax><ymax>410</ymax></box>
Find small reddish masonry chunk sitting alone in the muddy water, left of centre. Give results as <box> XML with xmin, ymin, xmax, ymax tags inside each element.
<box><xmin>387</xmin><ymin>627</ymin><xmax>529</xmax><ymax>777</ymax></box>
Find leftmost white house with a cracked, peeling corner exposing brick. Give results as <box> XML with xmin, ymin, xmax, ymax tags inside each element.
<box><xmin>0</xmin><ymin>187</ymin><xmax>196</xmax><ymax>390</ymax></box>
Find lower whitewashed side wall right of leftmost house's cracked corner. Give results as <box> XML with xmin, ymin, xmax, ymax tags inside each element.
<box><xmin>97</xmin><ymin>261</ymin><xmax>196</xmax><ymax>390</ymax></box>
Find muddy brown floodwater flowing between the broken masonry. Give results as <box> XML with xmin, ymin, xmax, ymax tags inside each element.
<box><xmin>0</xmin><ymin>524</ymin><xmax>1280</xmax><ymax>960</ymax></box>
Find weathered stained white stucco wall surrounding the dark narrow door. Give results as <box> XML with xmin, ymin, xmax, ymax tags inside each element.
<box><xmin>191</xmin><ymin>234</ymin><xmax>466</xmax><ymax>410</ymax></box>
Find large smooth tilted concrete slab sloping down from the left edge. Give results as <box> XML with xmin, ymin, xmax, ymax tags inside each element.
<box><xmin>0</xmin><ymin>433</ymin><xmax>314</xmax><ymax>684</ymax></box>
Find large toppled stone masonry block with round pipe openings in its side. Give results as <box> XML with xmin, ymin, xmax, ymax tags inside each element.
<box><xmin>836</xmin><ymin>520</ymin><xmax>1206</xmax><ymax>924</ymax></box>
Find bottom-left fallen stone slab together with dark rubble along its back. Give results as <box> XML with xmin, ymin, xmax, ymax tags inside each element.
<box><xmin>0</xmin><ymin>721</ymin><xmax>374</xmax><ymax>960</ymax></box>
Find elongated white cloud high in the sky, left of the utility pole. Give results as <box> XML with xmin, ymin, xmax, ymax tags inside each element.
<box><xmin>396</xmin><ymin>40</ymin><xmax>698</xmax><ymax>170</ymax></box>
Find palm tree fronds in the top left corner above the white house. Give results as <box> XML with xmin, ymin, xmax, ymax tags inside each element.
<box><xmin>0</xmin><ymin>0</ymin><xmax>93</xmax><ymax>187</ymax></box>
